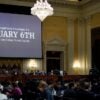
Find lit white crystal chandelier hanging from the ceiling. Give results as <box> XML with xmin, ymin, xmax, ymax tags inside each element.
<box><xmin>31</xmin><ymin>0</ymin><xmax>53</xmax><ymax>21</ymax></box>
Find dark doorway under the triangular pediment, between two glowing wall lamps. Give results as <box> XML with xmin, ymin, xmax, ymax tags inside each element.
<box><xmin>46</xmin><ymin>51</ymin><xmax>64</xmax><ymax>73</ymax></box>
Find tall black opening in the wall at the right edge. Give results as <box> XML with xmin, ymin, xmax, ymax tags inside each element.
<box><xmin>91</xmin><ymin>27</ymin><xmax>100</xmax><ymax>72</ymax></box>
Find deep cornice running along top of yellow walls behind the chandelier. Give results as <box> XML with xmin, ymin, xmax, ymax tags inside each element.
<box><xmin>0</xmin><ymin>0</ymin><xmax>100</xmax><ymax>17</ymax></box>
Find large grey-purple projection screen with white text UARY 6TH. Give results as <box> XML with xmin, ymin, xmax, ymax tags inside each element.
<box><xmin>0</xmin><ymin>13</ymin><xmax>42</xmax><ymax>58</ymax></box>
